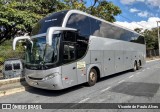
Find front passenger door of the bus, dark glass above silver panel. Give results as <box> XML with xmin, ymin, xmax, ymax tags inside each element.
<box><xmin>62</xmin><ymin>32</ymin><xmax>78</xmax><ymax>88</ymax></box>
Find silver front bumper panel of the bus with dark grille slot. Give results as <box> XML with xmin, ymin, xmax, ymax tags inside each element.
<box><xmin>25</xmin><ymin>67</ymin><xmax>64</xmax><ymax>90</ymax></box>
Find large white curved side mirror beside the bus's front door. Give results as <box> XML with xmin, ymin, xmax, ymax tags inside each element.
<box><xmin>46</xmin><ymin>27</ymin><xmax>77</xmax><ymax>46</ymax></box>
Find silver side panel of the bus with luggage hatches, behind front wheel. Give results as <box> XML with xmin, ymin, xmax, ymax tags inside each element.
<box><xmin>89</xmin><ymin>36</ymin><xmax>146</xmax><ymax>77</ymax></box>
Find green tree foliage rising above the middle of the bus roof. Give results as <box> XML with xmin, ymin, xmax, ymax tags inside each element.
<box><xmin>64</xmin><ymin>0</ymin><xmax>121</xmax><ymax>22</ymax></box>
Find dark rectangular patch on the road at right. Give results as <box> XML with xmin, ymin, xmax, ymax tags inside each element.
<box><xmin>111</xmin><ymin>82</ymin><xmax>160</xmax><ymax>97</ymax></box>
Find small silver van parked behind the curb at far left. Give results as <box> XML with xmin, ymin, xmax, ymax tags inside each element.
<box><xmin>2</xmin><ymin>59</ymin><xmax>23</xmax><ymax>79</ymax></box>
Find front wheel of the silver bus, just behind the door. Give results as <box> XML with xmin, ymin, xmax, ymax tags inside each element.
<box><xmin>87</xmin><ymin>68</ymin><xmax>97</xmax><ymax>86</ymax></box>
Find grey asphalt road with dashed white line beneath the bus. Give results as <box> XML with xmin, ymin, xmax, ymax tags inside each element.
<box><xmin>0</xmin><ymin>60</ymin><xmax>160</xmax><ymax>112</ymax></box>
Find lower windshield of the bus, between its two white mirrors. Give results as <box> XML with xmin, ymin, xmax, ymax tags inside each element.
<box><xmin>26</xmin><ymin>34</ymin><xmax>60</xmax><ymax>65</ymax></box>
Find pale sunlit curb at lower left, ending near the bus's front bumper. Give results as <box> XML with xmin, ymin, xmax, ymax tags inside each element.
<box><xmin>0</xmin><ymin>86</ymin><xmax>30</xmax><ymax>97</ymax></box>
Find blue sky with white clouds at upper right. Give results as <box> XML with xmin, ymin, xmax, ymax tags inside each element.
<box><xmin>87</xmin><ymin>0</ymin><xmax>160</xmax><ymax>30</ymax></box>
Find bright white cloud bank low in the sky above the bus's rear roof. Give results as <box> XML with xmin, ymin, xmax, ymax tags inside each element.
<box><xmin>114</xmin><ymin>17</ymin><xmax>160</xmax><ymax>30</ymax></box>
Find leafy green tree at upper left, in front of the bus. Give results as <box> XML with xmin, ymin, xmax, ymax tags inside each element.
<box><xmin>0</xmin><ymin>0</ymin><xmax>43</xmax><ymax>43</ymax></box>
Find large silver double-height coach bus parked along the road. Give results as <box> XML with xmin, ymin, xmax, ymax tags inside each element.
<box><xmin>13</xmin><ymin>10</ymin><xmax>146</xmax><ymax>90</ymax></box>
